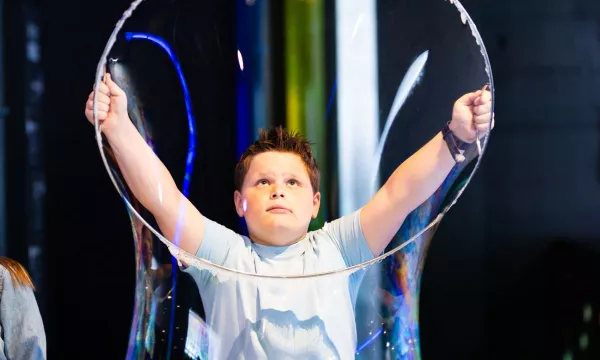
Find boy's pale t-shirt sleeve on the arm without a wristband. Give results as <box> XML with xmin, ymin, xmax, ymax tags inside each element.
<box><xmin>183</xmin><ymin>217</ymin><xmax>246</xmax><ymax>286</ymax></box>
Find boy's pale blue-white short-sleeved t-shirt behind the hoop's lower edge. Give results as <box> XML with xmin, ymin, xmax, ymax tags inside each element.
<box><xmin>185</xmin><ymin>210</ymin><xmax>373</xmax><ymax>359</ymax></box>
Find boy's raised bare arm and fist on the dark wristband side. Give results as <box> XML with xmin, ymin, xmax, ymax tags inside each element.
<box><xmin>360</xmin><ymin>90</ymin><xmax>492</xmax><ymax>256</ymax></box>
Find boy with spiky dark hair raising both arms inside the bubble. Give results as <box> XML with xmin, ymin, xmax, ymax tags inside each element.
<box><xmin>85</xmin><ymin>74</ymin><xmax>492</xmax><ymax>359</ymax></box>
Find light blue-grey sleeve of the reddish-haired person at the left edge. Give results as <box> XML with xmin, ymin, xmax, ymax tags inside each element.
<box><xmin>0</xmin><ymin>267</ymin><xmax>46</xmax><ymax>360</ymax></box>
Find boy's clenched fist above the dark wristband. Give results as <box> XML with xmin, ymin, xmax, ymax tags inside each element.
<box><xmin>449</xmin><ymin>85</ymin><xmax>494</xmax><ymax>143</ymax></box>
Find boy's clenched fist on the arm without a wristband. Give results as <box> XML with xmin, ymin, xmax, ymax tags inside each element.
<box><xmin>85</xmin><ymin>73</ymin><xmax>128</xmax><ymax>132</ymax></box>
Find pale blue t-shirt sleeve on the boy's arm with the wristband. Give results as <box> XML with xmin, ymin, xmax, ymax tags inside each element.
<box><xmin>323</xmin><ymin>210</ymin><xmax>374</xmax><ymax>266</ymax></box>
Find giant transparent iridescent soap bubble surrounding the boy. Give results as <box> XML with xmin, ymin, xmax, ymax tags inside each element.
<box><xmin>89</xmin><ymin>0</ymin><xmax>494</xmax><ymax>359</ymax></box>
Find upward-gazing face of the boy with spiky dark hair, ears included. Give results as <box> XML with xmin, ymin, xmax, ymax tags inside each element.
<box><xmin>234</xmin><ymin>152</ymin><xmax>321</xmax><ymax>246</ymax></box>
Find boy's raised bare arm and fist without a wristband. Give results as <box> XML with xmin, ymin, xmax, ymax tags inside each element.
<box><xmin>85</xmin><ymin>74</ymin><xmax>204</xmax><ymax>254</ymax></box>
